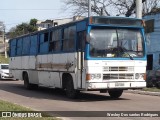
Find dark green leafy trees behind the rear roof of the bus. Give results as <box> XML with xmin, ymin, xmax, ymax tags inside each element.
<box><xmin>8</xmin><ymin>19</ymin><xmax>37</xmax><ymax>38</ymax></box>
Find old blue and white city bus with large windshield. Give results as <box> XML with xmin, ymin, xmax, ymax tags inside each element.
<box><xmin>9</xmin><ymin>16</ymin><xmax>147</xmax><ymax>98</ymax></box>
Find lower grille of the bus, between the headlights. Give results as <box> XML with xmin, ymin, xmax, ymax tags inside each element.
<box><xmin>103</xmin><ymin>74</ymin><xmax>134</xmax><ymax>80</ymax></box>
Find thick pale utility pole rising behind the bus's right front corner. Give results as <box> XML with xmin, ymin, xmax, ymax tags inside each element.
<box><xmin>136</xmin><ymin>0</ymin><xmax>142</xmax><ymax>19</ymax></box>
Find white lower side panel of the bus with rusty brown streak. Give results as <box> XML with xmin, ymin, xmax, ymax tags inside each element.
<box><xmin>10</xmin><ymin>53</ymin><xmax>82</xmax><ymax>89</ymax></box>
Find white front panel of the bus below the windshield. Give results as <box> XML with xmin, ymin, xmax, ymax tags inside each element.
<box><xmin>85</xmin><ymin>60</ymin><xmax>147</xmax><ymax>89</ymax></box>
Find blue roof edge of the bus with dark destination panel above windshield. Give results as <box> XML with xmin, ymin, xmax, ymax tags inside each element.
<box><xmin>9</xmin><ymin>16</ymin><xmax>143</xmax><ymax>39</ymax></box>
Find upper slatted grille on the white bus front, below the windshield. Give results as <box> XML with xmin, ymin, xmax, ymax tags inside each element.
<box><xmin>103</xmin><ymin>67</ymin><xmax>134</xmax><ymax>72</ymax></box>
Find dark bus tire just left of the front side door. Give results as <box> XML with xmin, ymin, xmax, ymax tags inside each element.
<box><xmin>66</xmin><ymin>79</ymin><xmax>79</xmax><ymax>99</ymax></box>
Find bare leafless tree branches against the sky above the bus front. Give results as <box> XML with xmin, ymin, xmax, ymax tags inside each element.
<box><xmin>63</xmin><ymin>0</ymin><xmax>160</xmax><ymax>17</ymax></box>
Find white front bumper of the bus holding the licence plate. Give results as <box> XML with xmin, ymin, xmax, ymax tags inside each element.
<box><xmin>86</xmin><ymin>81</ymin><xmax>146</xmax><ymax>90</ymax></box>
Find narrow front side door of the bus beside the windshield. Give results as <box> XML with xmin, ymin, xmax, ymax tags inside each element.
<box><xmin>77</xmin><ymin>31</ymin><xmax>86</xmax><ymax>88</ymax></box>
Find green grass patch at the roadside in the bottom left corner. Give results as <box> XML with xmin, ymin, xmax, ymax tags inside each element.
<box><xmin>0</xmin><ymin>100</ymin><xmax>60</xmax><ymax>120</ymax></box>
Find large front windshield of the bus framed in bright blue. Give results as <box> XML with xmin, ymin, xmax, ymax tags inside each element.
<box><xmin>90</xmin><ymin>29</ymin><xmax>144</xmax><ymax>58</ymax></box>
